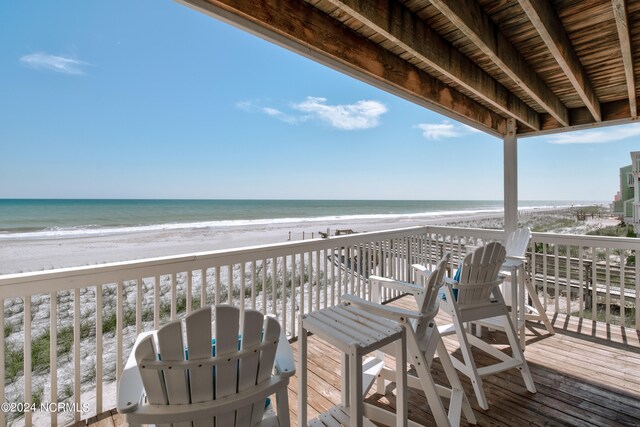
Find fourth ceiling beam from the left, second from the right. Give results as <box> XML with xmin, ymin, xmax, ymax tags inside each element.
<box><xmin>518</xmin><ymin>0</ymin><xmax>602</xmax><ymax>122</ymax></box>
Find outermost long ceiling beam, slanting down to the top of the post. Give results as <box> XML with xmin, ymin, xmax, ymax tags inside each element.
<box><xmin>178</xmin><ymin>0</ymin><xmax>506</xmax><ymax>136</ymax></box>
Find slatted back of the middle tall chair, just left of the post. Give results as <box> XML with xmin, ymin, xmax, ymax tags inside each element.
<box><xmin>457</xmin><ymin>242</ymin><xmax>506</xmax><ymax>305</ymax></box>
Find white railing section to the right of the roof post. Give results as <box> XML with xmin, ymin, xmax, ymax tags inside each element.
<box><xmin>529</xmin><ymin>233</ymin><xmax>640</xmax><ymax>329</ymax></box>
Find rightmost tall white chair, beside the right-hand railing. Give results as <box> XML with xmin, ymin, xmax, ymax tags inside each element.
<box><xmin>476</xmin><ymin>227</ymin><xmax>555</xmax><ymax>350</ymax></box>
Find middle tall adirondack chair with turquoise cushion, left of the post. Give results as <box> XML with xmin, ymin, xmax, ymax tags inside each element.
<box><xmin>439</xmin><ymin>242</ymin><xmax>536</xmax><ymax>409</ymax></box>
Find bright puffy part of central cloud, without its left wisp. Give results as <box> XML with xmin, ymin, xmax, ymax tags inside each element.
<box><xmin>293</xmin><ymin>96</ymin><xmax>387</xmax><ymax>130</ymax></box>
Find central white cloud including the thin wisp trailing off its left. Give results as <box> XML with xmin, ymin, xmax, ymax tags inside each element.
<box><xmin>236</xmin><ymin>96</ymin><xmax>387</xmax><ymax>130</ymax></box>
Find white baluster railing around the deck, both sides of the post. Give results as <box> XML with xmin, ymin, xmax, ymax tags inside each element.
<box><xmin>0</xmin><ymin>227</ymin><xmax>640</xmax><ymax>424</ymax></box>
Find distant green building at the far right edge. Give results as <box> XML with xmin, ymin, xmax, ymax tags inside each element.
<box><xmin>612</xmin><ymin>151</ymin><xmax>640</xmax><ymax>234</ymax></box>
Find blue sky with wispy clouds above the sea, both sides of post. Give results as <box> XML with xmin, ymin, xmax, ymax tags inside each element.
<box><xmin>0</xmin><ymin>0</ymin><xmax>640</xmax><ymax>200</ymax></box>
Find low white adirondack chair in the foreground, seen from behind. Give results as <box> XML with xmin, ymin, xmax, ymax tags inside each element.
<box><xmin>118</xmin><ymin>305</ymin><xmax>295</xmax><ymax>427</ymax></box>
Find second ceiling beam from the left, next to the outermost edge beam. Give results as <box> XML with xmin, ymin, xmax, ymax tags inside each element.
<box><xmin>328</xmin><ymin>0</ymin><xmax>540</xmax><ymax>130</ymax></box>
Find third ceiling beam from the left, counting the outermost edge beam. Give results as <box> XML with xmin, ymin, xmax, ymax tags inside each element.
<box><xmin>430</xmin><ymin>0</ymin><xmax>569</xmax><ymax>126</ymax></box>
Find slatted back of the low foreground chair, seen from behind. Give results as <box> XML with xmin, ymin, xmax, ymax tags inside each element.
<box><xmin>136</xmin><ymin>305</ymin><xmax>280</xmax><ymax>427</ymax></box>
